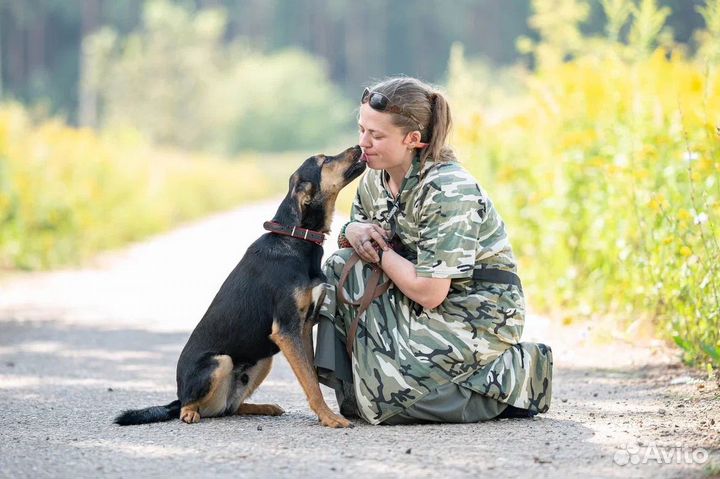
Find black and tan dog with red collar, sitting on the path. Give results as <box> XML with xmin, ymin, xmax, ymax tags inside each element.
<box><xmin>115</xmin><ymin>146</ymin><xmax>366</xmax><ymax>427</ymax></box>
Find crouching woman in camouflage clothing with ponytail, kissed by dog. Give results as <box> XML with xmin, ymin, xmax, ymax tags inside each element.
<box><xmin>315</xmin><ymin>77</ymin><xmax>552</xmax><ymax>424</ymax></box>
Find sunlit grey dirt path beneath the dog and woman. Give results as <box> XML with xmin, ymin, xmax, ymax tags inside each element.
<box><xmin>0</xmin><ymin>201</ymin><xmax>720</xmax><ymax>478</ymax></box>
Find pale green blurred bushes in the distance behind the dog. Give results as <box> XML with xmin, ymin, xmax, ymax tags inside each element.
<box><xmin>87</xmin><ymin>0</ymin><xmax>350</xmax><ymax>153</ymax></box>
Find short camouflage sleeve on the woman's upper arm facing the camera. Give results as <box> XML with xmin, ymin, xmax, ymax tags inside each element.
<box><xmin>415</xmin><ymin>169</ymin><xmax>487</xmax><ymax>278</ymax></box>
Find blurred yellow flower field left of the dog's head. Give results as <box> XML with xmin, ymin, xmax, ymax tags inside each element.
<box><xmin>0</xmin><ymin>105</ymin><xmax>298</xmax><ymax>269</ymax></box>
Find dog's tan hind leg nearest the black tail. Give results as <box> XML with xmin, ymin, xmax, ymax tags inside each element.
<box><xmin>180</xmin><ymin>354</ymin><xmax>233</xmax><ymax>424</ymax></box>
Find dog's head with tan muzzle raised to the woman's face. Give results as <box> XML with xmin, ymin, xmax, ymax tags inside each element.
<box><xmin>278</xmin><ymin>146</ymin><xmax>367</xmax><ymax>233</ymax></box>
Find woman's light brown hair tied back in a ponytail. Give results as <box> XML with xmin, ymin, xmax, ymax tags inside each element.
<box><xmin>362</xmin><ymin>77</ymin><xmax>455</xmax><ymax>165</ymax></box>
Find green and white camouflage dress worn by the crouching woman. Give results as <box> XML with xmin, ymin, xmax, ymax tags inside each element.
<box><xmin>318</xmin><ymin>158</ymin><xmax>552</xmax><ymax>424</ymax></box>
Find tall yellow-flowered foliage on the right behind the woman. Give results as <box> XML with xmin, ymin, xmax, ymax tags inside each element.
<box><xmin>449</xmin><ymin>0</ymin><xmax>720</xmax><ymax>368</ymax></box>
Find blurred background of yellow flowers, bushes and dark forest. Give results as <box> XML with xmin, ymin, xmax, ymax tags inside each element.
<box><xmin>0</xmin><ymin>0</ymin><xmax>720</xmax><ymax>374</ymax></box>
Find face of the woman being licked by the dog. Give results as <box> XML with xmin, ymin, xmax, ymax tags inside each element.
<box><xmin>358</xmin><ymin>103</ymin><xmax>412</xmax><ymax>170</ymax></box>
